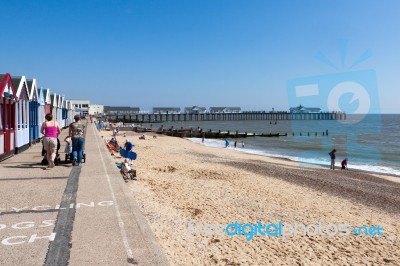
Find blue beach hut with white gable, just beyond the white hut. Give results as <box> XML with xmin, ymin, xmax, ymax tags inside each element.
<box><xmin>27</xmin><ymin>79</ymin><xmax>40</xmax><ymax>143</ymax></box>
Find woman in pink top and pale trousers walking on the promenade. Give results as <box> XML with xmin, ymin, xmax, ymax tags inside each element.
<box><xmin>40</xmin><ymin>113</ymin><xmax>61</xmax><ymax>168</ymax></box>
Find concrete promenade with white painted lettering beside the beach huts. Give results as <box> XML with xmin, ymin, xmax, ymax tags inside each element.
<box><xmin>0</xmin><ymin>123</ymin><xmax>168</xmax><ymax>265</ymax></box>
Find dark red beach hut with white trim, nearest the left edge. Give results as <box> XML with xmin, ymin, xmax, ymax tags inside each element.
<box><xmin>0</xmin><ymin>73</ymin><xmax>17</xmax><ymax>160</ymax></box>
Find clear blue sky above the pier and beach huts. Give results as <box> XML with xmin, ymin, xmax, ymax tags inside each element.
<box><xmin>0</xmin><ymin>0</ymin><xmax>400</xmax><ymax>113</ymax></box>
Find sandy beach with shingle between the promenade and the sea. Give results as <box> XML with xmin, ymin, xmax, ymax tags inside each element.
<box><xmin>104</xmin><ymin>131</ymin><xmax>400</xmax><ymax>265</ymax></box>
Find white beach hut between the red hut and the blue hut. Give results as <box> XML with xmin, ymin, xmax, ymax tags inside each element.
<box><xmin>12</xmin><ymin>76</ymin><xmax>29</xmax><ymax>153</ymax></box>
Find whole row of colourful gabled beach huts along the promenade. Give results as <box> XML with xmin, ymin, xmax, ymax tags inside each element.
<box><xmin>0</xmin><ymin>73</ymin><xmax>74</xmax><ymax>161</ymax></box>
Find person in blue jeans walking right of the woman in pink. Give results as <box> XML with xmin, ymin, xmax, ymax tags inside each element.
<box><xmin>69</xmin><ymin>115</ymin><xmax>85</xmax><ymax>166</ymax></box>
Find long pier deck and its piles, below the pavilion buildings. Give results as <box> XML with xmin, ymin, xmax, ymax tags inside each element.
<box><xmin>105</xmin><ymin>112</ymin><xmax>346</xmax><ymax>123</ymax></box>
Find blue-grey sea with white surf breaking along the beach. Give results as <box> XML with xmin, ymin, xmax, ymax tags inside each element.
<box><xmin>145</xmin><ymin>114</ymin><xmax>400</xmax><ymax>177</ymax></box>
